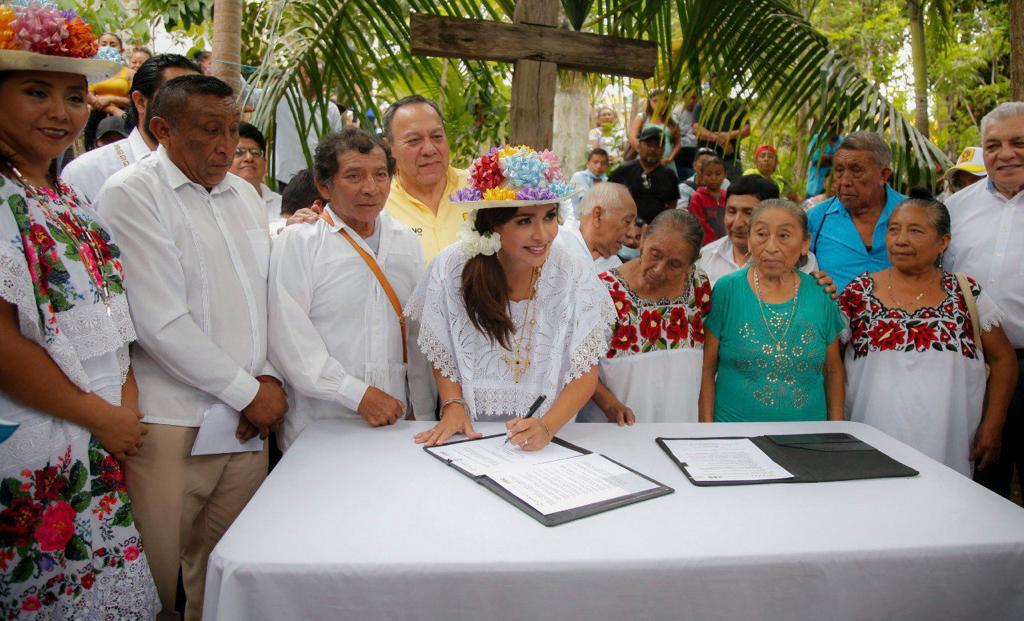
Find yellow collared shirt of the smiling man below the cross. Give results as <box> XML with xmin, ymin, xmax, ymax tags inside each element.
<box><xmin>384</xmin><ymin>166</ymin><xmax>469</xmax><ymax>263</ymax></box>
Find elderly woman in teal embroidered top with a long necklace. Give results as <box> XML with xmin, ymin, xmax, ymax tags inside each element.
<box><xmin>699</xmin><ymin>199</ymin><xmax>844</xmax><ymax>422</ymax></box>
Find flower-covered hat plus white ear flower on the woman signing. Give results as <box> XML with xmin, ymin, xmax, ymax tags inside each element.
<box><xmin>449</xmin><ymin>144</ymin><xmax>582</xmax><ymax>256</ymax></box>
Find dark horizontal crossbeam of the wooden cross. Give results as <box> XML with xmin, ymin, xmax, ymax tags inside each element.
<box><xmin>410</xmin><ymin>13</ymin><xmax>657</xmax><ymax>79</ymax></box>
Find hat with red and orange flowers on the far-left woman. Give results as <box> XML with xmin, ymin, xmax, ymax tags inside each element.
<box><xmin>0</xmin><ymin>0</ymin><xmax>121</xmax><ymax>82</ymax></box>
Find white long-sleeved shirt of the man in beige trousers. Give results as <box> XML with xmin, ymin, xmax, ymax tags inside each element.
<box><xmin>96</xmin><ymin>147</ymin><xmax>275</xmax><ymax>427</ymax></box>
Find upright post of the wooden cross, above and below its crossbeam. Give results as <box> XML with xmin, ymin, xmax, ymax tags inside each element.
<box><xmin>509</xmin><ymin>0</ymin><xmax>561</xmax><ymax>150</ymax></box>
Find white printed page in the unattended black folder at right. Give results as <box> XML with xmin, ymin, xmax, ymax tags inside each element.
<box><xmin>665</xmin><ymin>438</ymin><xmax>793</xmax><ymax>482</ymax></box>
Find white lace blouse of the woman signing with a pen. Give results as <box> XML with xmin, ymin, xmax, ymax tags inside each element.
<box><xmin>406</xmin><ymin>244</ymin><xmax>615</xmax><ymax>420</ymax></box>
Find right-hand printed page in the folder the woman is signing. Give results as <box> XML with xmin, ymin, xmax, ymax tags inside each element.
<box><xmin>490</xmin><ymin>453</ymin><xmax>657</xmax><ymax>515</ymax></box>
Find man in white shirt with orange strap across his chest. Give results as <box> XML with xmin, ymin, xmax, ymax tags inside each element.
<box><xmin>269</xmin><ymin>128</ymin><xmax>435</xmax><ymax>451</ymax></box>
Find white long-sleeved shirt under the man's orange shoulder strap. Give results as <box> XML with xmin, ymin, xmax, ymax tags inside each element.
<box><xmin>269</xmin><ymin>208</ymin><xmax>436</xmax><ymax>450</ymax></box>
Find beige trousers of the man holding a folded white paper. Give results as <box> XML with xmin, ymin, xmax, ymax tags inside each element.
<box><xmin>125</xmin><ymin>424</ymin><xmax>267</xmax><ymax>621</ymax></box>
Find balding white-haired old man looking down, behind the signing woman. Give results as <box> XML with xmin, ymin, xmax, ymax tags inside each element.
<box><xmin>555</xmin><ymin>181</ymin><xmax>637</xmax><ymax>274</ymax></box>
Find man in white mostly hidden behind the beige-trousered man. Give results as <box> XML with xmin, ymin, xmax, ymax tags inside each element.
<box><xmin>60</xmin><ymin>54</ymin><xmax>200</xmax><ymax>202</ymax></box>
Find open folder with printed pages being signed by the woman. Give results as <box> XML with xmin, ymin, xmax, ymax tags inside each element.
<box><xmin>425</xmin><ymin>434</ymin><xmax>673</xmax><ymax>526</ymax></box>
